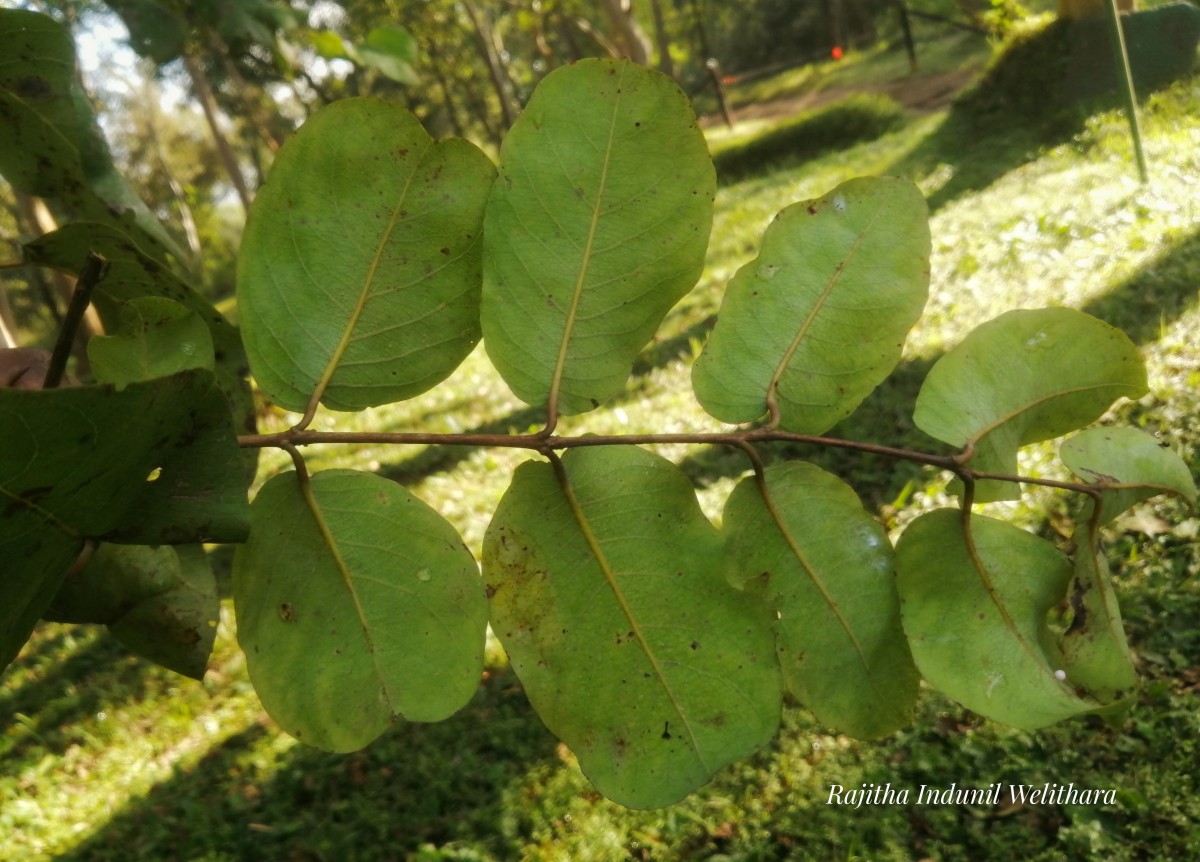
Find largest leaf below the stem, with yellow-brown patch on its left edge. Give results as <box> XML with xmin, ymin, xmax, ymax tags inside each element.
<box><xmin>484</xmin><ymin>447</ymin><xmax>781</xmax><ymax>808</ymax></box>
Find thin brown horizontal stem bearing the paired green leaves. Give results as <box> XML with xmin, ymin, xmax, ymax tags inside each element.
<box><xmin>238</xmin><ymin>426</ymin><xmax>1097</xmax><ymax>495</ymax></box>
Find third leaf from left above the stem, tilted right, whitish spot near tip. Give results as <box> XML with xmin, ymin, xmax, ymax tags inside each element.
<box><xmin>692</xmin><ymin>178</ymin><xmax>930</xmax><ymax>433</ymax></box>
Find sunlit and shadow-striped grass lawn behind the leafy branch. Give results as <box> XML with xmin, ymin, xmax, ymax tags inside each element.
<box><xmin>0</xmin><ymin>20</ymin><xmax>1200</xmax><ymax>862</ymax></box>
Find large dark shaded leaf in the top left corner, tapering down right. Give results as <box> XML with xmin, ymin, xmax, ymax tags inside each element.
<box><xmin>0</xmin><ymin>10</ymin><xmax>185</xmax><ymax>265</ymax></box>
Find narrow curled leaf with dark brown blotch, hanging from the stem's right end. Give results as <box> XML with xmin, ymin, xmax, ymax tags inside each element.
<box><xmin>1060</xmin><ymin>501</ymin><xmax>1138</xmax><ymax>714</ymax></box>
